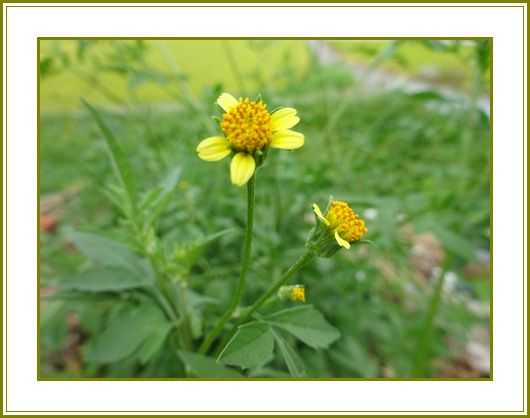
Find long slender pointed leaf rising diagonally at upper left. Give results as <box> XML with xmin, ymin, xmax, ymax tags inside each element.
<box><xmin>82</xmin><ymin>100</ymin><xmax>137</xmax><ymax>206</ymax></box>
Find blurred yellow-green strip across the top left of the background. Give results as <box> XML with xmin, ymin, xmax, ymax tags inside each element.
<box><xmin>41</xmin><ymin>40</ymin><xmax>309</xmax><ymax>112</ymax></box>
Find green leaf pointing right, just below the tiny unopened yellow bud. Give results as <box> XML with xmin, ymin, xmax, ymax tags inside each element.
<box><xmin>266</xmin><ymin>305</ymin><xmax>340</xmax><ymax>349</ymax></box>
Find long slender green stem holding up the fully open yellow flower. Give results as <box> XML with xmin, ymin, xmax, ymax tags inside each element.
<box><xmin>199</xmin><ymin>174</ymin><xmax>256</xmax><ymax>353</ymax></box>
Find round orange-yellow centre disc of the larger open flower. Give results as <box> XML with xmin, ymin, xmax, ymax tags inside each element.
<box><xmin>221</xmin><ymin>99</ymin><xmax>272</xmax><ymax>154</ymax></box>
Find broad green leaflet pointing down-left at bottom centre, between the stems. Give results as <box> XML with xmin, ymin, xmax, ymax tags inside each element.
<box><xmin>219</xmin><ymin>322</ymin><xmax>274</xmax><ymax>369</ymax></box>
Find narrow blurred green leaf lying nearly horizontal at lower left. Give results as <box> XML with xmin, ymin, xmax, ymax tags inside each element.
<box><xmin>63</xmin><ymin>267</ymin><xmax>151</xmax><ymax>292</ymax></box>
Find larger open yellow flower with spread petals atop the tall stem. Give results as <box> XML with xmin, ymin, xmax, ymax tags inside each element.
<box><xmin>197</xmin><ymin>93</ymin><xmax>304</xmax><ymax>186</ymax></box>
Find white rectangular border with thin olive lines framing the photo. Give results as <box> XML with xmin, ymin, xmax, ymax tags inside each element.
<box><xmin>3</xmin><ymin>3</ymin><xmax>527</xmax><ymax>415</ymax></box>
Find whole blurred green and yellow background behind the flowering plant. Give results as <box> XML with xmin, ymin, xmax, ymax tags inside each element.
<box><xmin>39</xmin><ymin>40</ymin><xmax>491</xmax><ymax>378</ymax></box>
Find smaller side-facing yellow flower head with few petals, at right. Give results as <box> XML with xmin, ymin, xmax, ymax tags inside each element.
<box><xmin>313</xmin><ymin>200</ymin><xmax>368</xmax><ymax>248</ymax></box>
